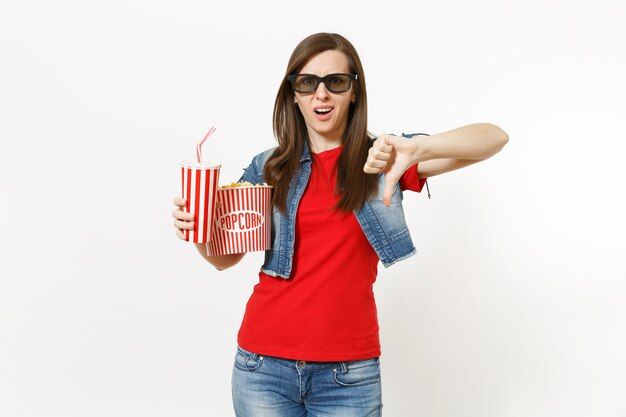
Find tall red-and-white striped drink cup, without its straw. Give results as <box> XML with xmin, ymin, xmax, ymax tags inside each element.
<box><xmin>181</xmin><ymin>161</ymin><xmax>222</xmax><ymax>243</ymax></box>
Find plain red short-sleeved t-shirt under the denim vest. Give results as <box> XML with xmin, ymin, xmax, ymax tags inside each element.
<box><xmin>238</xmin><ymin>147</ymin><xmax>425</xmax><ymax>361</ymax></box>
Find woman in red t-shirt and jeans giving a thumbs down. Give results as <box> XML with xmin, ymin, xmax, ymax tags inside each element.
<box><xmin>173</xmin><ymin>33</ymin><xmax>508</xmax><ymax>417</ymax></box>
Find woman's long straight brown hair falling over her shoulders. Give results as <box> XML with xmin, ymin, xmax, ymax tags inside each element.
<box><xmin>263</xmin><ymin>33</ymin><xmax>378</xmax><ymax>212</ymax></box>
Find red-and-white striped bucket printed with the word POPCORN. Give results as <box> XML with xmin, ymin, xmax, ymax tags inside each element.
<box><xmin>206</xmin><ymin>185</ymin><xmax>272</xmax><ymax>256</ymax></box>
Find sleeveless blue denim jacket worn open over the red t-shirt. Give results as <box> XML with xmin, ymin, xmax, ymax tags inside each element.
<box><xmin>239</xmin><ymin>135</ymin><xmax>416</xmax><ymax>279</ymax></box>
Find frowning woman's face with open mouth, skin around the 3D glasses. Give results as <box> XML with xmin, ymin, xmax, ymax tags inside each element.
<box><xmin>294</xmin><ymin>50</ymin><xmax>355</xmax><ymax>142</ymax></box>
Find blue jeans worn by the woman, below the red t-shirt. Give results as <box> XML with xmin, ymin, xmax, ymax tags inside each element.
<box><xmin>232</xmin><ymin>347</ymin><xmax>382</xmax><ymax>417</ymax></box>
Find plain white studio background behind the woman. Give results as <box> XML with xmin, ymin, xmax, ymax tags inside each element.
<box><xmin>0</xmin><ymin>0</ymin><xmax>626</xmax><ymax>417</ymax></box>
